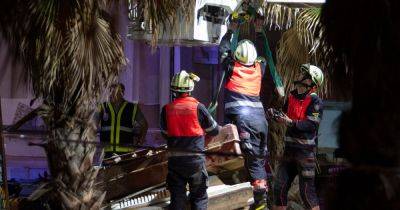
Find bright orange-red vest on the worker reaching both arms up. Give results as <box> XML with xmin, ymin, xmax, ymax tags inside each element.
<box><xmin>225</xmin><ymin>61</ymin><xmax>262</xmax><ymax>96</ymax></box>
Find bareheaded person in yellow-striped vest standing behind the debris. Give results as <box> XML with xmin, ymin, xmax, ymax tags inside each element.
<box><xmin>98</xmin><ymin>83</ymin><xmax>148</xmax><ymax>158</ymax></box>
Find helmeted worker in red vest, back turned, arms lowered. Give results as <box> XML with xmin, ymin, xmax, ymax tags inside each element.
<box><xmin>160</xmin><ymin>70</ymin><xmax>220</xmax><ymax>210</ymax></box>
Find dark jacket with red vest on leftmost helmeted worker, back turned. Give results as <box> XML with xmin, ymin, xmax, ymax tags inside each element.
<box><xmin>160</xmin><ymin>96</ymin><xmax>219</xmax><ymax>159</ymax></box>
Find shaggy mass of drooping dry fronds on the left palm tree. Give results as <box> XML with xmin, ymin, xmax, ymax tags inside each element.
<box><xmin>2</xmin><ymin>0</ymin><xmax>126</xmax><ymax>122</ymax></box>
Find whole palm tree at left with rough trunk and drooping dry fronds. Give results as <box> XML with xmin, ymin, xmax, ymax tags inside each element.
<box><xmin>0</xmin><ymin>0</ymin><xmax>126</xmax><ymax>209</ymax></box>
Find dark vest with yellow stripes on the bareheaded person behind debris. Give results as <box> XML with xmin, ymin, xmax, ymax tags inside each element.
<box><xmin>100</xmin><ymin>101</ymin><xmax>137</xmax><ymax>152</ymax></box>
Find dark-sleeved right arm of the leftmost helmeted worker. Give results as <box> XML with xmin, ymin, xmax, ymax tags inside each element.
<box><xmin>197</xmin><ymin>103</ymin><xmax>220</xmax><ymax>136</ymax></box>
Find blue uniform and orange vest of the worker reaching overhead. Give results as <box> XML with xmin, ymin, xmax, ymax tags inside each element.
<box><xmin>219</xmin><ymin>31</ymin><xmax>268</xmax><ymax>182</ymax></box>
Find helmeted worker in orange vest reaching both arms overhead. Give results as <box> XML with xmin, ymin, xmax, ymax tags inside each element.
<box><xmin>219</xmin><ymin>18</ymin><xmax>268</xmax><ymax>209</ymax></box>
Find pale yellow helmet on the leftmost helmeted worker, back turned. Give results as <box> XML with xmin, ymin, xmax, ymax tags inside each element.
<box><xmin>171</xmin><ymin>70</ymin><xmax>200</xmax><ymax>93</ymax></box>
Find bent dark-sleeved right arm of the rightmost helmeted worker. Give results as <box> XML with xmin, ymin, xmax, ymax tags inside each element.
<box><xmin>292</xmin><ymin>95</ymin><xmax>323</xmax><ymax>132</ymax></box>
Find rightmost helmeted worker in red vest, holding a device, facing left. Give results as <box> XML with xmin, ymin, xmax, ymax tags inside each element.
<box><xmin>269</xmin><ymin>64</ymin><xmax>324</xmax><ymax>210</ymax></box>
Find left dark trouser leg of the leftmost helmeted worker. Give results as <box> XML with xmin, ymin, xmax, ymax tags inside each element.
<box><xmin>167</xmin><ymin>163</ymin><xmax>187</xmax><ymax>210</ymax></box>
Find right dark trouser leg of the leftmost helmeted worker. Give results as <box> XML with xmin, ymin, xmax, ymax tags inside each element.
<box><xmin>189</xmin><ymin>164</ymin><xmax>208</xmax><ymax>210</ymax></box>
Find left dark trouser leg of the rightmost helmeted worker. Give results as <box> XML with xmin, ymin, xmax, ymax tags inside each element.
<box><xmin>272</xmin><ymin>148</ymin><xmax>297</xmax><ymax>210</ymax></box>
